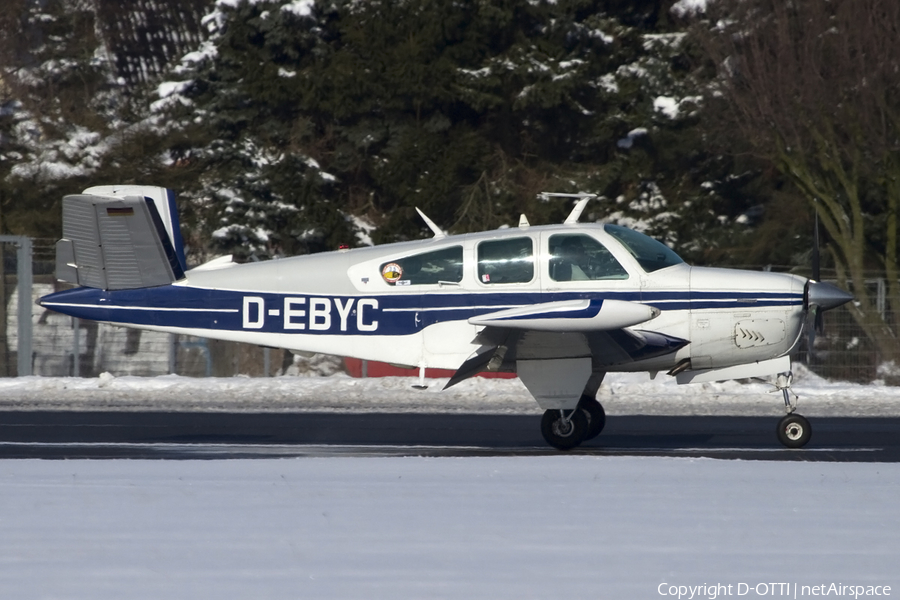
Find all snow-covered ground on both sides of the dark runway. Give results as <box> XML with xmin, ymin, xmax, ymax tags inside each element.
<box><xmin>0</xmin><ymin>372</ymin><xmax>900</xmax><ymax>600</ymax></box>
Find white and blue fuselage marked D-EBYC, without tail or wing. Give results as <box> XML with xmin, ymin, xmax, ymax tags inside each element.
<box><xmin>42</xmin><ymin>224</ymin><xmax>806</xmax><ymax>371</ymax></box>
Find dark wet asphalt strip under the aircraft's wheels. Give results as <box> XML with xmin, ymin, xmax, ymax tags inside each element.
<box><xmin>0</xmin><ymin>411</ymin><xmax>900</xmax><ymax>462</ymax></box>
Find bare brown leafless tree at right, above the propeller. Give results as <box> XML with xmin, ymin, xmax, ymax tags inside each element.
<box><xmin>695</xmin><ymin>0</ymin><xmax>900</xmax><ymax>360</ymax></box>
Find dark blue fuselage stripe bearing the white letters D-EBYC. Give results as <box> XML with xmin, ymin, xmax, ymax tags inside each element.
<box><xmin>41</xmin><ymin>286</ymin><xmax>803</xmax><ymax>335</ymax></box>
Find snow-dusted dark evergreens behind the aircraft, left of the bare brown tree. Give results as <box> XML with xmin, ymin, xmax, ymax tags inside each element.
<box><xmin>0</xmin><ymin>0</ymin><xmax>767</xmax><ymax>262</ymax></box>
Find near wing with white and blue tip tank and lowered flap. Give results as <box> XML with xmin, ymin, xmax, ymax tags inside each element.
<box><xmin>444</xmin><ymin>299</ymin><xmax>689</xmax><ymax>389</ymax></box>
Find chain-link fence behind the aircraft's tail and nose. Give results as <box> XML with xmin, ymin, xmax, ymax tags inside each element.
<box><xmin>0</xmin><ymin>236</ymin><xmax>900</xmax><ymax>383</ymax></box>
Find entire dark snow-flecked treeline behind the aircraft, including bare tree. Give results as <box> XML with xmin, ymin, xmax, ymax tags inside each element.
<box><xmin>0</xmin><ymin>0</ymin><xmax>900</xmax><ymax>366</ymax></box>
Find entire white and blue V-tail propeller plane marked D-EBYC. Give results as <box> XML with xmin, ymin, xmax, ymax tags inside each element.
<box><xmin>40</xmin><ymin>186</ymin><xmax>851</xmax><ymax>449</ymax></box>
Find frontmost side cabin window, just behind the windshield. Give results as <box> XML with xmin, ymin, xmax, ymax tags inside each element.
<box><xmin>550</xmin><ymin>234</ymin><xmax>628</xmax><ymax>281</ymax></box>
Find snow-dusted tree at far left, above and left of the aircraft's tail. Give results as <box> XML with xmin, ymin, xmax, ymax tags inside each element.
<box><xmin>0</xmin><ymin>0</ymin><xmax>109</xmax><ymax>237</ymax></box>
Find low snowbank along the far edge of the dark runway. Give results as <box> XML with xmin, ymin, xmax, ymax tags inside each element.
<box><xmin>0</xmin><ymin>366</ymin><xmax>900</xmax><ymax>416</ymax></box>
